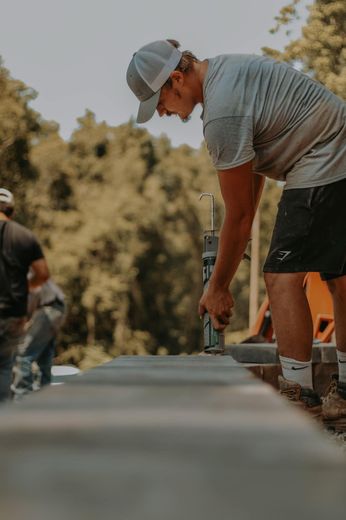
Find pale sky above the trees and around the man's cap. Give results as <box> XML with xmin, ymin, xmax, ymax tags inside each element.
<box><xmin>0</xmin><ymin>0</ymin><xmax>312</xmax><ymax>147</ymax></box>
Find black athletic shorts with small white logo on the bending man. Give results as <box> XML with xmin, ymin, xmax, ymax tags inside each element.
<box><xmin>263</xmin><ymin>179</ymin><xmax>346</xmax><ymax>280</ymax></box>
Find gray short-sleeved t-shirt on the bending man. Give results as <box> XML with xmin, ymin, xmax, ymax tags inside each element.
<box><xmin>201</xmin><ymin>54</ymin><xmax>346</xmax><ymax>189</ymax></box>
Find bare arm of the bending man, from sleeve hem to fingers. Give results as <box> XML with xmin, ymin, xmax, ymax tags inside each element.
<box><xmin>199</xmin><ymin>162</ymin><xmax>264</xmax><ymax>330</ymax></box>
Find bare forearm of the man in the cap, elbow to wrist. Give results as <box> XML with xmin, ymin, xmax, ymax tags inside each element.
<box><xmin>209</xmin><ymin>214</ymin><xmax>252</xmax><ymax>288</ymax></box>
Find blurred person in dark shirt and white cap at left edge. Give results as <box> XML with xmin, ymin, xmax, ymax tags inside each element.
<box><xmin>0</xmin><ymin>188</ymin><xmax>49</xmax><ymax>402</ymax></box>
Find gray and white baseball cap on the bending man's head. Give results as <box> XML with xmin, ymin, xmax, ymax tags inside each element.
<box><xmin>126</xmin><ymin>40</ymin><xmax>182</xmax><ymax>123</ymax></box>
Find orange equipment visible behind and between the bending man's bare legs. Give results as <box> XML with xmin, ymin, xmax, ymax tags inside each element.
<box><xmin>250</xmin><ymin>273</ymin><xmax>334</xmax><ymax>343</ymax></box>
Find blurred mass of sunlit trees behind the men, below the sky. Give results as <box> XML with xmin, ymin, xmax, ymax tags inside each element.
<box><xmin>0</xmin><ymin>52</ymin><xmax>282</xmax><ymax>367</ymax></box>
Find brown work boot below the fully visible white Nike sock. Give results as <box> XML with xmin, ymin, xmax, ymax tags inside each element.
<box><xmin>278</xmin><ymin>376</ymin><xmax>322</xmax><ymax>419</ymax></box>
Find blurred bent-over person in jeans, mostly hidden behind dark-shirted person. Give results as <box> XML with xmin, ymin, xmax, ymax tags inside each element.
<box><xmin>11</xmin><ymin>279</ymin><xmax>66</xmax><ymax>397</ymax></box>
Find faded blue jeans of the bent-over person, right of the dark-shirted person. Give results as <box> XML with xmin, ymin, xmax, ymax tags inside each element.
<box><xmin>12</xmin><ymin>305</ymin><xmax>64</xmax><ymax>394</ymax></box>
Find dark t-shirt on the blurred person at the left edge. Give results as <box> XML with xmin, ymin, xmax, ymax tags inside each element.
<box><xmin>0</xmin><ymin>220</ymin><xmax>43</xmax><ymax>318</ymax></box>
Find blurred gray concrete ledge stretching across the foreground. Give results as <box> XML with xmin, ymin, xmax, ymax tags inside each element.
<box><xmin>0</xmin><ymin>356</ymin><xmax>346</xmax><ymax>520</ymax></box>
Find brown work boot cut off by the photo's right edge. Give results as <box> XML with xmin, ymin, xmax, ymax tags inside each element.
<box><xmin>322</xmin><ymin>375</ymin><xmax>346</xmax><ymax>432</ymax></box>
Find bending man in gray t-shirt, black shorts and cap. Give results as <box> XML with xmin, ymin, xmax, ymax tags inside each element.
<box><xmin>127</xmin><ymin>40</ymin><xmax>346</xmax><ymax>428</ymax></box>
